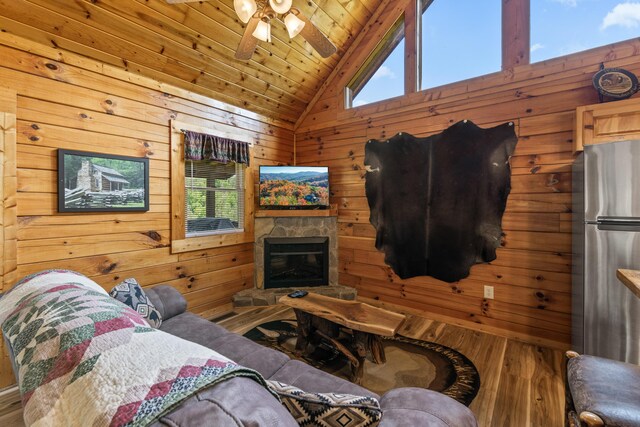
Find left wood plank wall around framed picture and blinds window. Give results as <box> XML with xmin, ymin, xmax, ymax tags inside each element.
<box><xmin>0</xmin><ymin>33</ymin><xmax>293</xmax><ymax>387</ymax></box>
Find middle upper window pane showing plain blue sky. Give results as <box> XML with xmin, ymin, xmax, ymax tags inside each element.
<box><xmin>421</xmin><ymin>0</ymin><xmax>502</xmax><ymax>89</ymax></box>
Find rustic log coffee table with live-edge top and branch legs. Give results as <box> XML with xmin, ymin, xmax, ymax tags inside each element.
<box><xmin>279</xmin><ymin>292</ymin><xmax>405</xmax><ymax>384</ymax></box>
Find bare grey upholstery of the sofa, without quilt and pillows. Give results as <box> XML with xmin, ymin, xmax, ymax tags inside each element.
<box><xmin>145</xmin><ymin>285</ymin><xmax>477</xmax><ymax>427</ymax></box>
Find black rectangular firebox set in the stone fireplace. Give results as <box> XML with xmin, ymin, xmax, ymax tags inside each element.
<box><xmin>264</xmin><ymin>237</ymin><xmax>329</xmax><ymax>289</ymax></box>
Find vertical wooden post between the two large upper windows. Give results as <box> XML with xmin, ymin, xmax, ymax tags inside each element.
<box><xmin>502</xmin><ymin>0</ymin><xmax>530</xmax><ymax>70</ymax></box>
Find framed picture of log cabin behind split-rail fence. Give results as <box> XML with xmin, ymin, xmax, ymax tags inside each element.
<box><xmin>58</xmin><ymin>149</ymin><xmax>149</xmax><ymax>212</ymax></box>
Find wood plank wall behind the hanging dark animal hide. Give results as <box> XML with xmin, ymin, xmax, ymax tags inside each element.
<box><xmin>296</xmin><ymin>13</ymin><xmax>640</xmax><ymax>348</ymax></box>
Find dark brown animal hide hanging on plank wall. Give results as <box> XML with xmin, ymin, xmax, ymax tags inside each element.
<box><xmin>364</xmin><ymin>121</ymin><xmax>517</xmax><ymax>282</ymax></box>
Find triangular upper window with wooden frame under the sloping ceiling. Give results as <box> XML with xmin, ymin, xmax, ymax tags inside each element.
<box><xmin>346</xmin><ymin>18</ymin><xmax>404</xmax><ymax>108</ymax></box>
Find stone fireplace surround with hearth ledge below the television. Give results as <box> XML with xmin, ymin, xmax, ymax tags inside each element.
<box><xmin>233</xmin><ymin>217</ymin><xmax>356</xmax><ymax>307</ymax></box>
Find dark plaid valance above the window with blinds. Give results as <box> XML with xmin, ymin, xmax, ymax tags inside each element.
<box><xmin>182</xmin><ymin>130</ymin><xmax>250</xmax><ymax>166</ymax></box>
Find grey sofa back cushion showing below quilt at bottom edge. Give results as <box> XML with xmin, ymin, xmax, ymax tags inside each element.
<box><xmin>152</xmin><ymin>378</ymin><xmax>298</xmax><ymax>427</ymax></box>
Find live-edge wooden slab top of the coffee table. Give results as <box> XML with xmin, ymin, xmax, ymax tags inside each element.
<box><xmin>279</xmin><ymin>292</ymin><xmax>405</xmax><ymax>337</ymax></box>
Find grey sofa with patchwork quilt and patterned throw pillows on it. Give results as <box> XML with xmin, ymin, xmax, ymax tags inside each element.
<box><xmin>0</xmin><ymin>270</ymin><xmax>477</xmax><ymax>427</ymax></box>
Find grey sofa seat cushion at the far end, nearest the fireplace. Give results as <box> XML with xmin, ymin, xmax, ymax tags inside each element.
<box><xmin>161</xmin><ymin>313</ymin><xmax>289</xmax><ymax>378</ymax></box>
